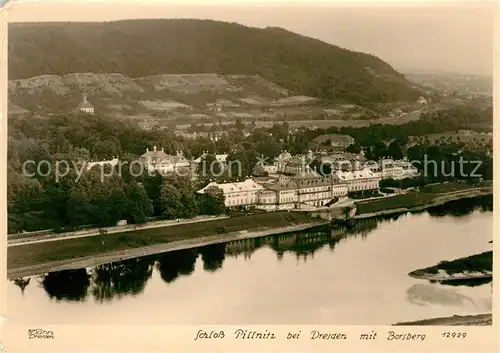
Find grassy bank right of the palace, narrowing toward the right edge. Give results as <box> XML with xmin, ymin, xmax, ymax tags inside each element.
<box><xmin>356</xmin><ymin>183</ymin><xmax>493</xmax><ymax>216</ymax></box>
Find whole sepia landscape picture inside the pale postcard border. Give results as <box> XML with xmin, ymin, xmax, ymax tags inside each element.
<box><xmin>0</xmin><ymin>1</ymin><xmax>495</xmax><ymax>330</ymax></box>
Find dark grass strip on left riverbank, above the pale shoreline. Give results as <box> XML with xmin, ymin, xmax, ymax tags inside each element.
<box><xmin>7</xmin><ymin>212</ymin><xmax>317</xmax><ymax>270</ymax></box>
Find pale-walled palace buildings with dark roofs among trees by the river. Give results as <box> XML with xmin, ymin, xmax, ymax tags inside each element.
<box><xmin>85</xmin><ymin>146</ymin><xmax>417</xmax><ymax>211</ymax></box>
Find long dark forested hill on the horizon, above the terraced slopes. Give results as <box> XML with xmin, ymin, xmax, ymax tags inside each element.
<box><xmin>9</xmin><ymin>19</ymin><xmax>419</xmax><ymax>104</ymax></box>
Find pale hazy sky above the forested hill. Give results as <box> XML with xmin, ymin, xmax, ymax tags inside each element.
<box><xmin>4</xmin><ymin>0</ymin><xmax>498</xmax><ymax>74</ymax></box>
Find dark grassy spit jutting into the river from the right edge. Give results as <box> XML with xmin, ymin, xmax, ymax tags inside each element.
<box><xmin>409</xmin><ymin>251</ymin><xmax>493</xmax><ymax>281</ymax></box>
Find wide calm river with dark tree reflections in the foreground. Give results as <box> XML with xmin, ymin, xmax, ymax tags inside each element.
<box><xmin>7</xmin><ymin>198</ymin><xmax>493</xmax><ymax>325</ymax></box>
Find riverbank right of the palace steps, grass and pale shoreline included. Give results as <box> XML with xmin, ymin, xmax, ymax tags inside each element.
<box><xmin>352</xmin><ymin>187</ymin><xmax>493</xmax><ymax>219</ymax></box>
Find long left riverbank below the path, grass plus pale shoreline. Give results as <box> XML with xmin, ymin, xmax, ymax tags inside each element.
<box><xmin>7</xmin><ymin>212</ymin><xmax>328</xmax><ymax>279</ymax></box>
